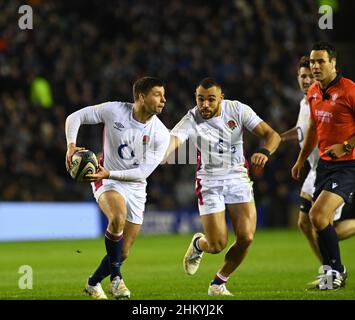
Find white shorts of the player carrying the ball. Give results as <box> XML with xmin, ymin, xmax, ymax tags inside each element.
<box><xmin>91</xmin><ymin>179</ymin><xmax>147</xmax><ymax>224</ymax></box>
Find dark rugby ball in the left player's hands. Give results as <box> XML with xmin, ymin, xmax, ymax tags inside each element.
<box><xmin>69</xmin><ymin>150</ymin><xmax>99</xmax><ymax>181</ymax></box>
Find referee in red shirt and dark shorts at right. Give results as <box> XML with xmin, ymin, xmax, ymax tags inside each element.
<box><xmin>292</xmin><ymin>42</ymin><xmax>355</xmax><ymax>290</ymax></box>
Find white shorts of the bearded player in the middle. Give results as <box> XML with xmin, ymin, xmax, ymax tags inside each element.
<box><xmin>196</xmin><ymin>175</ymin><xmax>254</xmax><ymax>215</ymax></box>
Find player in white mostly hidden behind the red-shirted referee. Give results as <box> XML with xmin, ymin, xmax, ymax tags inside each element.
<box><xmin>281</xmin><ymin>56</ymin><xmax>355</xmax><ymax>284</ymax></box>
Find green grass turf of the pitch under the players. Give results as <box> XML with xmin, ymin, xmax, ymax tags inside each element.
<box><xmin>0</xmin><ymin>230</ymin><xmax>355</xmax><ymax>300</ymax></box>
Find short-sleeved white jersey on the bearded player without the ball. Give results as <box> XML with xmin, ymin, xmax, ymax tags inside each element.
<box><xmin>170</xmin><ymin>100</ymin><xmax>262</xmax><ymax>180</ymax></box>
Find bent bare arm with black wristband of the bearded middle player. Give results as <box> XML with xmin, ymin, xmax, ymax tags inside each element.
<box><xmin>251</xmin><ymin>121</ymin><xmax>281</xmax><ymax>168</ymax></box>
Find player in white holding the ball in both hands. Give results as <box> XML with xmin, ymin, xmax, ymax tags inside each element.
<box><xmin>66</xmin><ymin>77</ymin><xmax>170</xmax><ymax>299</ymax></box>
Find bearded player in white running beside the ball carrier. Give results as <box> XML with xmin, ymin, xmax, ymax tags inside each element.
<box><xmin>166</xmin><ymin>78</ymin><xmax>281</xmax><ymax>296</ymax></box>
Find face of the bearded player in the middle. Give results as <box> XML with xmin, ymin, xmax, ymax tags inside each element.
<box><xmin>196</xmin><ymin>86</ymin><xmax>223</xmax><ymax>119</ymax></box>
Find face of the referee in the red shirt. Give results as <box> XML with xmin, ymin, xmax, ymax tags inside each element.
<box><xmin>309</xmin><ymin>50</ymin><xmax>336</xmax><ymax>82</ymax></box>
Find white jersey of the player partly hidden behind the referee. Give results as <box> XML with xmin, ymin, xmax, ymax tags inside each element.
<box><xmin>296</xmin><ymin>97</ymin><xmax>319</xmax><ymax>170</ymax></box>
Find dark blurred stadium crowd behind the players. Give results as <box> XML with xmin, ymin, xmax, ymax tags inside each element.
<box><xmin>0</xmin><ymin>0</ymin><xmax>329</xmax><ymax>226</ymax></box>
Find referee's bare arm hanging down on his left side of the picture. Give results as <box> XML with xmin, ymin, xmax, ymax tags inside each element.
<box><xmin>292</xmin><ymin>118</ymin><xmax>318</xmax><ymax>180</ymax></box>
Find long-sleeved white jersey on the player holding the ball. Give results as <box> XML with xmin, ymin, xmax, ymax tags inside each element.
<box><xmin>66</xmin><ymin>101</ymin><xmax>170</xmax><ymax>184</ymax></box>
